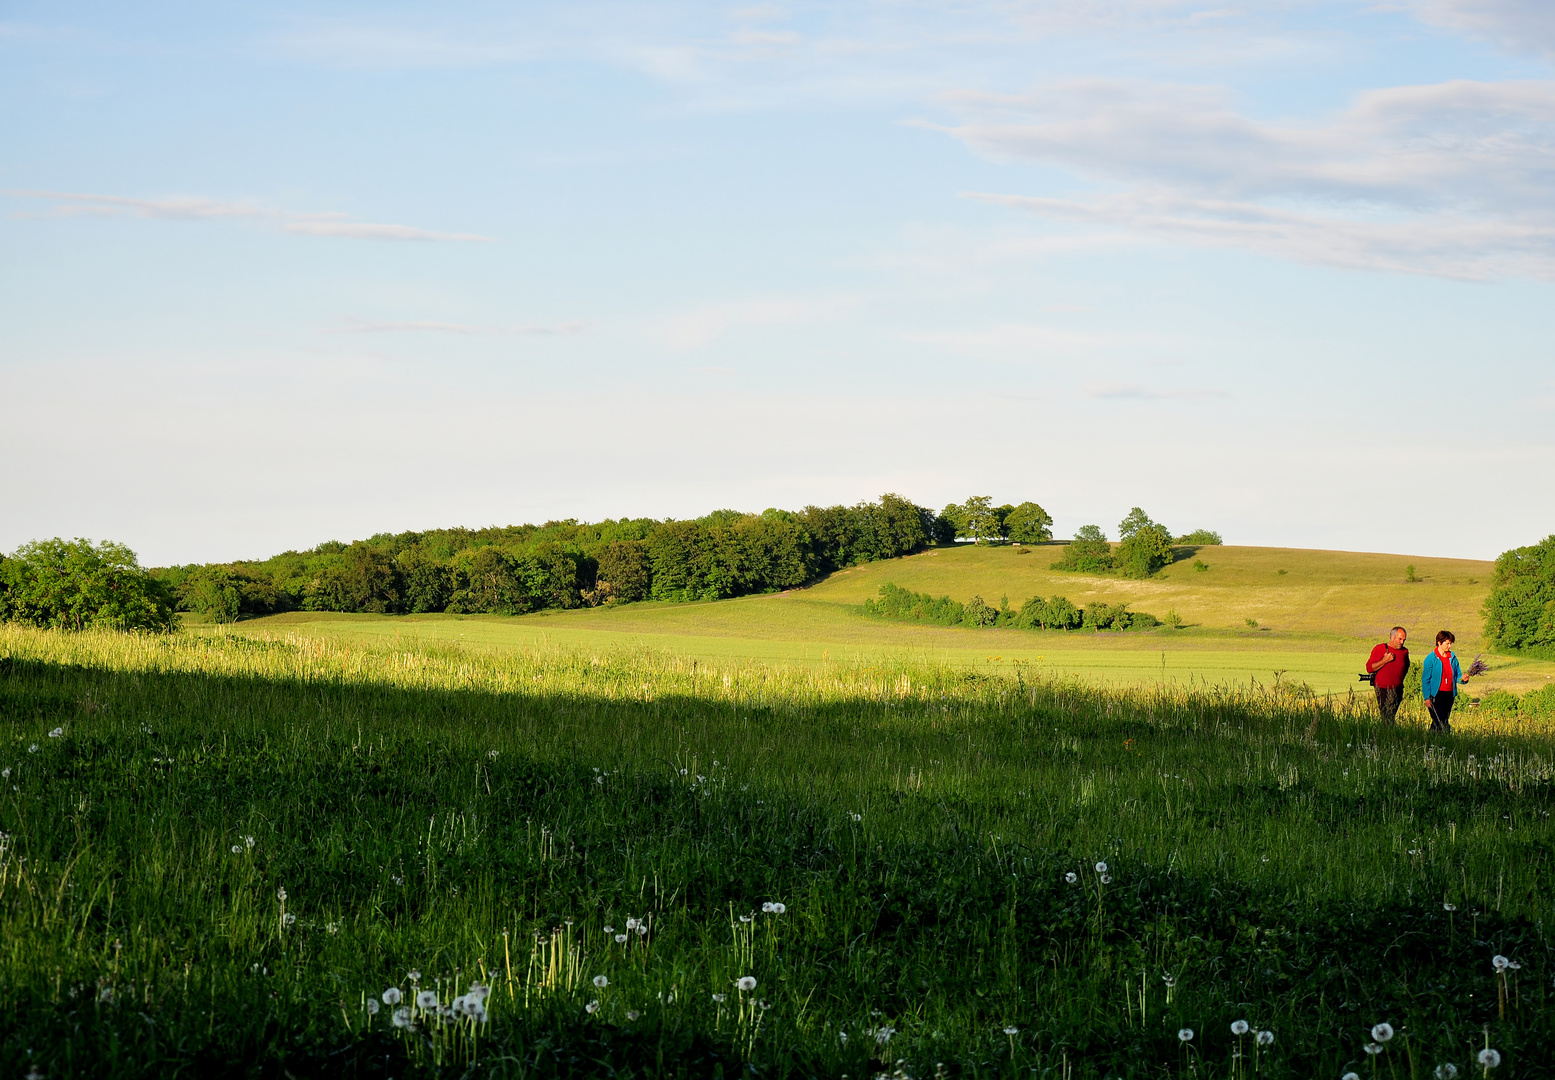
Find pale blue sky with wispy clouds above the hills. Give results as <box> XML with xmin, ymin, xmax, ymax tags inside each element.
<box><xmin>0</xmin><ymin>0</ymin><xmax>1555</xmax><ymax>564</ymax></box>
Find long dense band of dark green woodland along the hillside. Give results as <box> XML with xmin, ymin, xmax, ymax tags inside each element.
<box><xmin>157</xmin><ymin>494</ymin><xmax>945</xmax><ymax>620</ymax></box>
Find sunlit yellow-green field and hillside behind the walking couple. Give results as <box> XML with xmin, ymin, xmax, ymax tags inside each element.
<box><xmin>209</xmin><ymin>545</ymin><xmax>1555</xmax><ymax>693</ymax></box>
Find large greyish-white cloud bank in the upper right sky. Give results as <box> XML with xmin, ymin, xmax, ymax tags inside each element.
<box><xmin>945</xmin><ymin>79</ymin><xmax>1555</xmax><ymax>278</ymax></box>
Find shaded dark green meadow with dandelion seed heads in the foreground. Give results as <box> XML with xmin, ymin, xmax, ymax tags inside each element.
<box><xmin>0</xmin><ymin>629</ymin><xmax>1555</xmax><ymax>1080</ymax></box>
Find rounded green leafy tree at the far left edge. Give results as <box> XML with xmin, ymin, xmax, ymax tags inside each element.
<box><xmin>0</xmin><ymin>536</ymin><xmax>177</xmax><ymax>631</ymax></box>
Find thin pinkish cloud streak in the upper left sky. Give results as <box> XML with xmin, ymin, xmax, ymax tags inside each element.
<box><xmin>0</xmin><ymin>190</ymin><xmax>491</xmax><ymax>244</ymax></box>
